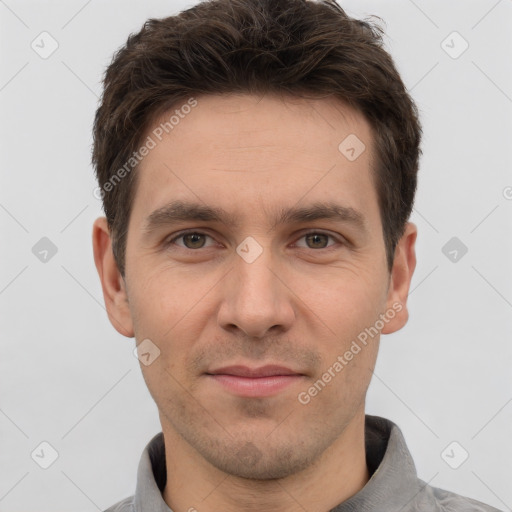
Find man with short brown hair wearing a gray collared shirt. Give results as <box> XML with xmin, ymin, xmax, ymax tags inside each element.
<box><xmin>93</xmin><ymin>0</ymin><xmax>496</xmax><ymax>512</ymax></box>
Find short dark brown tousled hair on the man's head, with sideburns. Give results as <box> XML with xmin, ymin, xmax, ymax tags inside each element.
<box><xmin>92</xmin><ymin>0</ymin><xmax>422</xmax><ymax>277</ymax></box>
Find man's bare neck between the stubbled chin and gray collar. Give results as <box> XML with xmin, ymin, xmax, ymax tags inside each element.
<box><xmin>162</xmin><ymin>409</ymin><xmax>370</xmax><ymax>512</ymax></box>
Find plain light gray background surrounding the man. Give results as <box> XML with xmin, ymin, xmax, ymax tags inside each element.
<box><xmin>0</xmin><ymin>0</ymin><xmax>512</xmax><ymax>512</ymax></box>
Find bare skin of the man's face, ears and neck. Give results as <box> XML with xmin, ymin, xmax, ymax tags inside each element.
<box><xmin>93</xmin><ymin>94</ymin><xmax>416</xmax><ymax>512</ymax></box>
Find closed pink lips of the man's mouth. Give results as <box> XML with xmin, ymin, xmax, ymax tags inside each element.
<box><xmin>206</xmin><ymin>365</ymin><xmax>305</xmax><ymax>398</ymax></box>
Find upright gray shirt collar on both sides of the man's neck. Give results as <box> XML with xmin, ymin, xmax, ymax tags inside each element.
<box><xmin>134</xmin><ymin>414</ymin><xmax>421</xmax><ymax>512</ymax></box>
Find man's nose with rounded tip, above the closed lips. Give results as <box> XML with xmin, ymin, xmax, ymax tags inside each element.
<box><xmin>218</xmin><ymin>244</ymin><xmax>295</xmax><ymax>338</ymax></box>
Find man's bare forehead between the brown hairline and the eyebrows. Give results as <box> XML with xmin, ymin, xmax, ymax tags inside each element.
<box><xmin>132</xmin><ymin>94</ymin><xmax>376</xmax><ymax>231</ymax></box>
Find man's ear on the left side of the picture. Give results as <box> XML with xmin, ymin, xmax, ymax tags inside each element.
<box><xmin>92</xmin><ymin>217</ymin><xmax>134</xmax><ymax>338</ymax></box>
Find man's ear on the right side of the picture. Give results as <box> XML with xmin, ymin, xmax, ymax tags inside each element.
<box><xmin>382</xmin><ymin>222</ymin><xmax>418</xmax><ymax>334</ymax></box>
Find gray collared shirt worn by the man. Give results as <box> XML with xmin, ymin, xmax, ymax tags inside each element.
<box><xmin>105</xmin><ymin>414</ymin><xmax>503</xmax><ymax>512</ymax></box>
